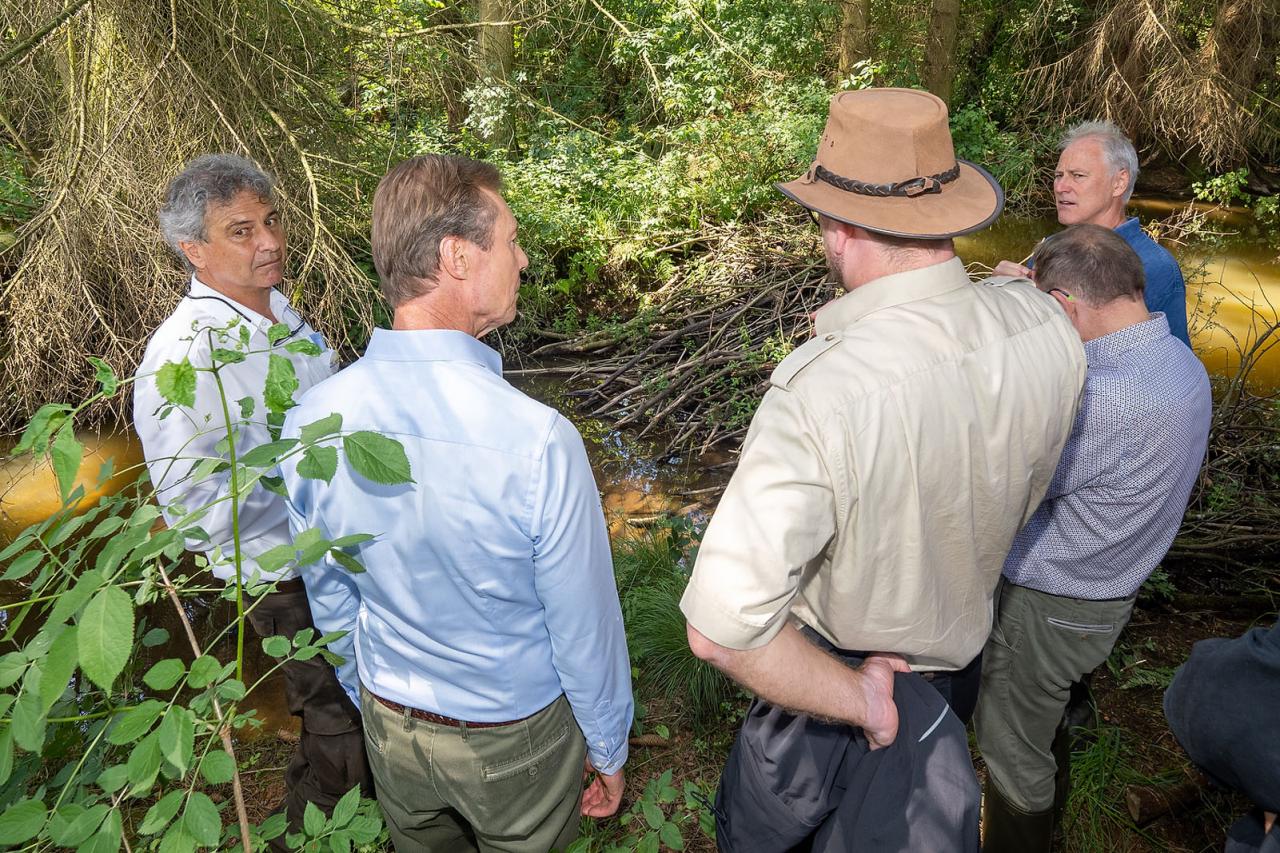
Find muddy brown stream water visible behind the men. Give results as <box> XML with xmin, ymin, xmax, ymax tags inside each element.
<box><xmin>0</xmin><ymin>200</ymin><xmax>1280</xmax><ymax>734</ymax></box>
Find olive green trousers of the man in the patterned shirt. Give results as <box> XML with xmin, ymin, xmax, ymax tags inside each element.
<box><xmin>973</xmin><ymin>580</ymin><xmax>1134</xmax><ymax>812</ymax></box>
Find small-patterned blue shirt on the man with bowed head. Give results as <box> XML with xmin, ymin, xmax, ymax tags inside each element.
<box><xmin>1004</xmin><ymin>314</ymin><xmax>1212</xmax><ymax>599</ymax></box>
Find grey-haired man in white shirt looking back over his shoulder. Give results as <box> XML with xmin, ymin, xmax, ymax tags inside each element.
<box><xmin>133</xmin><ymin>154</ymin><xmax>372</xmax><ymax>844</ymax></box>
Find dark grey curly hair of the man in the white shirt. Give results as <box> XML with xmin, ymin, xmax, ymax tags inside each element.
<box><xmin>157</xmin><ymin>154</ymin><xmax>275</xmax><ymax>270</ymax></box>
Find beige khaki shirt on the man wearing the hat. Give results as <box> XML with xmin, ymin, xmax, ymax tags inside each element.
<box><xmin>681</xmin><ymin>259</ymin><xmax>1085</xmax><ymax>670</ymax></box>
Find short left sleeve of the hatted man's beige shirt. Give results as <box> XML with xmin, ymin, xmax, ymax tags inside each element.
<box><xmin>680</xmin><ymin>388</ymin><xmax>852</xmax><ymax>649</ymax></box>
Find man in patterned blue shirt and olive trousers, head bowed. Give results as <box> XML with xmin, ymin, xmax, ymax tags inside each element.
<box><xmin>974</xmin><ymin>224</ymin><xmax>1211</xmax><ymax>853</ymax></box>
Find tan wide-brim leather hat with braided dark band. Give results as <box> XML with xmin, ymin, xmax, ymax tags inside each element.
<box><xmin>776</xmin><ymin>88</ymin><xmax>1005</xmax><ymax>240</ymax></box>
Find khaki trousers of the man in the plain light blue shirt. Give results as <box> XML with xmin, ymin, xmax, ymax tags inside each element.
<box><xmin>360</xmin><ymin>688</ymin><xmax>586</xmax><ymax>853</ymax></box>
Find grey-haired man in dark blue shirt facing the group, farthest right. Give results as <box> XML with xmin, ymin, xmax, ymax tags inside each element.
<box><xmin>995</xmin><ymin>122</ymin><xmax>1190</xmax><ymax>346</ymax></box>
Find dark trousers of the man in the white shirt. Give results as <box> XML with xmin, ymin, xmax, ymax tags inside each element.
<box><xmin>248</xmin><ymin>581</ymin><xmax>374</xmax><ymax>829</ymax></box>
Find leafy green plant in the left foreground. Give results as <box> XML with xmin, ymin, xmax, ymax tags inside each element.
<box><xmin>0</xmin><ymin>318</ymin><xmax>412</xmax><ymax>853</ymax></box>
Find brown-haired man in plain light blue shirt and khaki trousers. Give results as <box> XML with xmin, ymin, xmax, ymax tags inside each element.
<box><xmin>282</xmin><ymin>156</ymin><xmax>632</xmax><ymax>853</ymax></box>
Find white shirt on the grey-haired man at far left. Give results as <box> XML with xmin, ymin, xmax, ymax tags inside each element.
<box><xmin>133</xmin><ymin>275</ymin><xmax>337</xmax><ymax>580</ymax></box>
